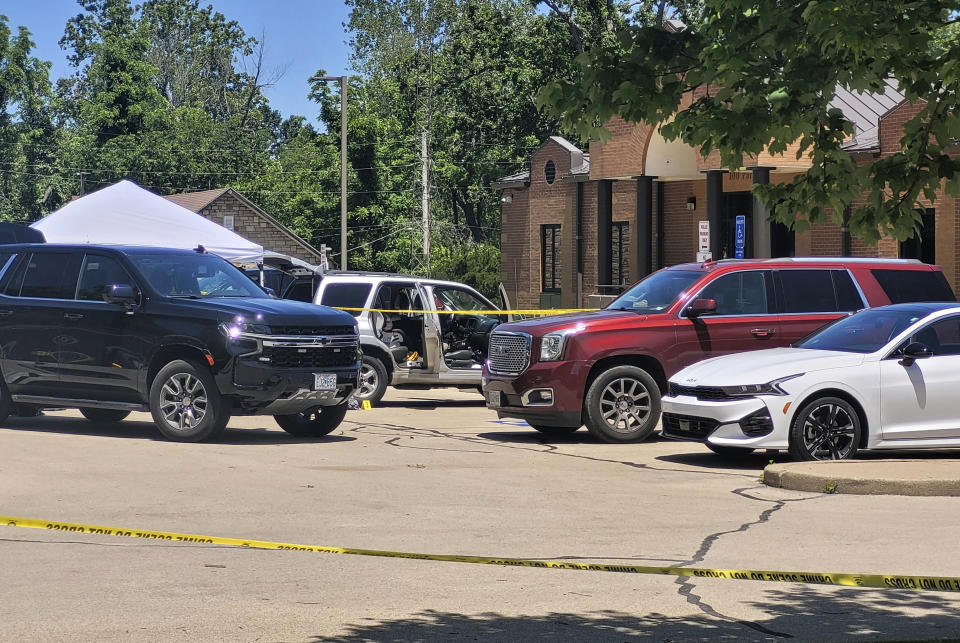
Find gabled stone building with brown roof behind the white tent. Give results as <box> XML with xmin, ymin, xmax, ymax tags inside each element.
<box><xmin>165</xmin><ymin>188</ymin><xmax>320</xmax><ymax>265</ymax></box>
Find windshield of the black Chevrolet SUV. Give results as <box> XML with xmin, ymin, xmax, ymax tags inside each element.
<box><xmin>130</xmin><ymin>253</ymin><xmax>267</xmax><ymax>299</ymax></box>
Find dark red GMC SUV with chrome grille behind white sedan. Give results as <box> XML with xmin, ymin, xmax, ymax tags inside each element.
<box><xmin>483</xmin><ymin>258</ymin><xmax>956</xmax><ymax>442</ymax></box>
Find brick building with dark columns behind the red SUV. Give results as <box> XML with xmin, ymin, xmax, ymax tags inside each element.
<box><xmin>493</xmin><ymin>85</ymin><xmax>960</xmax><ymax>308</ymax></box>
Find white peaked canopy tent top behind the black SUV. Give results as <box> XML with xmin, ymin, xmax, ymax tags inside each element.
<box><xmin>31</xmin><ymin>180</ymin><xmax>263</xmax><ymax>264</ymax></box>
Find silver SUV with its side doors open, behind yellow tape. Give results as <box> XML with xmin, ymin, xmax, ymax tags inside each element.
<box><xmin>314</xmin><ymin>271</ymin><xmax>507</xmax><ymax>403</ymax></box>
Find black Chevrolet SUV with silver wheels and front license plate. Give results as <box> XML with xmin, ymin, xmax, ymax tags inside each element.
<box><xmin>0</xmin><ymin>243</ymin><xmax>360</xmax><ymax>442</ymax></box>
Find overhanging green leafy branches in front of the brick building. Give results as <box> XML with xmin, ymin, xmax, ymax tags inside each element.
<box><xmin>539</xmin><ymin>0</ymin><xmax>960</xmax><ymax>241</ymax></box>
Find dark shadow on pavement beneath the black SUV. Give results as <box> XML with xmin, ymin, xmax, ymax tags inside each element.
<box><xmin>0</xmin><ymin>416</ymin><xmax>356</xmax><ymax>446</ymax></box>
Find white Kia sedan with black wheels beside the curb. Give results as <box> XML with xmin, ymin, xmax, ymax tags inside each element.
<box><xmin>662</xmin><ymin>303</ymin><xmax>960</xmax><ymax>460</ymax></box>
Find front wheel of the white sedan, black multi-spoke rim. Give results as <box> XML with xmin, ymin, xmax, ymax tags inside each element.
<box><xmin>790</xmin><ymin>396</ymin><xmax>863</xmax><ymax>460</ymax></box>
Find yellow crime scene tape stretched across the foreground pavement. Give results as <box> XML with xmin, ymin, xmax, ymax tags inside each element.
<box><xmin>0</xmin><ymin>516</ymin><xmax>960</xmax><ymax>592</ymax></box>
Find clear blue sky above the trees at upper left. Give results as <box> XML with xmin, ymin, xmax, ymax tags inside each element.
<box><xmin>0</xmin><ymin>0</ymin><xmax>350</xmax><ymax>122</ymax></box>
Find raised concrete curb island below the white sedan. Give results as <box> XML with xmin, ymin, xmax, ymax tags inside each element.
<box><xmin>763</xmin><ymin>460</ymin><xmax>960</xmax><ymax>496</ymax></box>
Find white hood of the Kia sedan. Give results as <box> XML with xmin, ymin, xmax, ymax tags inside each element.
<box><xmin>670</xmin><ymin>348</ymin><xmax>864</xmax><ymax>386</ymax></box>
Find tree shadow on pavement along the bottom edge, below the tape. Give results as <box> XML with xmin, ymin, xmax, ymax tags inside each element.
<box><xmin>311</xmin><ymin>585</ymin><xmax>960</xmax><ymax>642</ymax></box>
